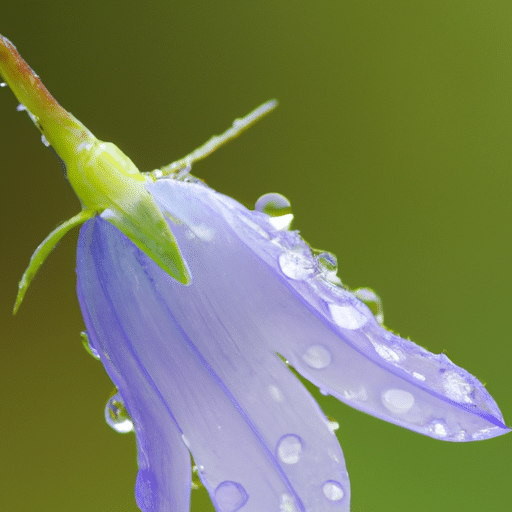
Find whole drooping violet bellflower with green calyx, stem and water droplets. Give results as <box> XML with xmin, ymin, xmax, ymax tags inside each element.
<box><xmin>0</xmin><ymin>38</ymin><xmax>509</xmax><ymax>512</ymax></box>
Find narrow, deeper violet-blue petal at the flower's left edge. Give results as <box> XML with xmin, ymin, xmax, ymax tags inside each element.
<box><xmin>77</xmin><ymin>228</ymin><xmax>191</xmax><ymax>512</ymax></box>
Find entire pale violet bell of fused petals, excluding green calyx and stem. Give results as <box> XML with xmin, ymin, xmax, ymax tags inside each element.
<box><xmin>77</xmin><ymin>174</ymin><xmax>508</xmax><ymax>512</ymax></box>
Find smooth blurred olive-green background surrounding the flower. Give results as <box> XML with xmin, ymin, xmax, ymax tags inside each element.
<box><xmin>0</xmin><ymin>0</ymin><xmax>512</xmax><ymax>512</ymax></box>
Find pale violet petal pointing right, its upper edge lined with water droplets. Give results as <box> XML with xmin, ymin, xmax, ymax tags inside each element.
<box><xmin>146</xmin><ymin>180</ymin><xmax>509</xmax><ymax>441</ymax></box>
